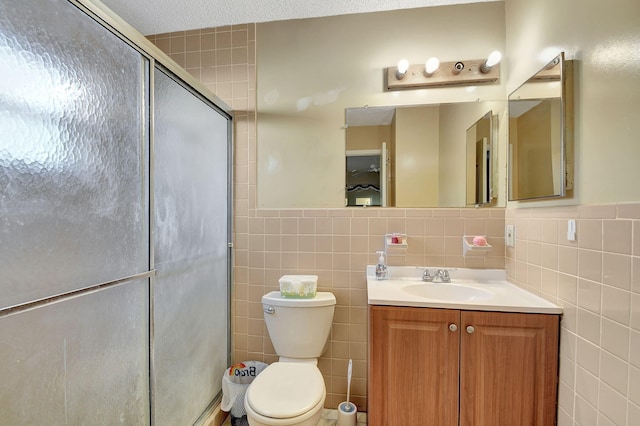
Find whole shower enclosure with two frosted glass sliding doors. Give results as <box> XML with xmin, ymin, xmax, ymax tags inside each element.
<box><xmin>0</xmin><ymin>0</ymin><xmax>232</xmax><ymax>425</ymax></box>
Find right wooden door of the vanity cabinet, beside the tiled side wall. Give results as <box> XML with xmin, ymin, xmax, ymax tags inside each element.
<box><xmin>460</xmin><ymin>312</ymin><xmax>559</xmax><ymax>426</ymax></box>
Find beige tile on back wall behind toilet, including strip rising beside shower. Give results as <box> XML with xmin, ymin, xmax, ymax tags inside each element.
<box><xmin>149</xmin><ymin>25</ymin><xmax>504</xmax><ymax>411</ymax></box>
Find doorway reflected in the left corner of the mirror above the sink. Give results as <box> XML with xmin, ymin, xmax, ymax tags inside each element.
<box><xmin>345</xmin><ymin>143</ymin><xmax>387</xmax><ymax>207</ymax></box>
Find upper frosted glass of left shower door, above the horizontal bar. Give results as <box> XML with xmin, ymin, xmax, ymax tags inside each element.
<box><xmin>0</xmin><ymin>0</ymin><xmax>149</xmax><ymax>309</ymax></box>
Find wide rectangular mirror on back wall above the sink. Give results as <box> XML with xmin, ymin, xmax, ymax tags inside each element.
<box><xmin>345</xmin><ymin>101</ymin><xmax>506</xmax><ymax>207</ymax></box>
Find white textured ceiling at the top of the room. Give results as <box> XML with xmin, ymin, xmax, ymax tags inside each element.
<box><xmin>102</xmin><ymin>0</ymin><xmax>494</xmax><ymax>35</ymax></box>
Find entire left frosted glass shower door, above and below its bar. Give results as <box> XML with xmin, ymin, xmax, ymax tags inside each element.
<box><xmin>0</xmin><ymin>0</ymin><xmax>151</xmax><ymax>425</ymax></box>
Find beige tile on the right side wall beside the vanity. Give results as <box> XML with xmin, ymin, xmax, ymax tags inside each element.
<box><xmin>506</xmin><ymin>204</ymin><xmax>640</xmax><ymax>426</ymax></box>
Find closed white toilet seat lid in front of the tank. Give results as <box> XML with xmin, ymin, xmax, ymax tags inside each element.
<box><xmin>245</xmin><ymin>362</ymin><xmax>326</xmax><ymax>420</ymax></box>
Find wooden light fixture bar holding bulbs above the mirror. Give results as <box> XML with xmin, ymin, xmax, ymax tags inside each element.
<box><xmin>385</xmin><ymin>59</ymin><xmax>500</xmax><ymax>91</ymax></box>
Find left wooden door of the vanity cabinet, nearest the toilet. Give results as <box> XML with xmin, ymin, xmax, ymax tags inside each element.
<box><xmin>367</xmin><ymin>306</ymin><xmax>460</xmax><ymax>426</ymax></box>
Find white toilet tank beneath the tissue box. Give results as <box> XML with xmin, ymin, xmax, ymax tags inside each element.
<box><xmin>262</xmin><ymin>291</ymin><xmax>336</xmax><ymax>358</ymax></box>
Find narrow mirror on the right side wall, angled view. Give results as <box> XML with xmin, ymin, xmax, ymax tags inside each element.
<box><xmin>509</xmin><ymin>53</ymin><xmax>573</xmax><ymax>201</ymax></box>
